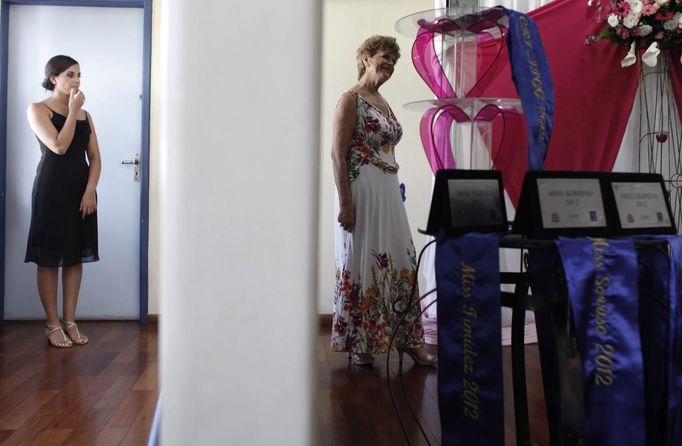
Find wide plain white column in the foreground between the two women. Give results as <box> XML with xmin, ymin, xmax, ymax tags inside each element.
<box><xmin>155</xmin><ymin>0</ymin><xmax>320</xmax><ymax>446</ymax></box>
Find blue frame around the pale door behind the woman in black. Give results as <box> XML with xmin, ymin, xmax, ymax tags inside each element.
<box><xmin>0</xmin><ymin>0</ymin><xmax>152</xmax><ymax>320</ymax></box>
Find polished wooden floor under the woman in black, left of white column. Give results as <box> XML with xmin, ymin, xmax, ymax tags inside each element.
<box><xmin>0</xmin><ymin>322</ymin><xmax>158</xmax><ymax>446</ymax></box>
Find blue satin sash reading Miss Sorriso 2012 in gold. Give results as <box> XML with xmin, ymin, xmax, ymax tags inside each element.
<box><xmin>557</xmin><ymin>237</ymin><xmax>645</xmax><ymax>446</ymax></box>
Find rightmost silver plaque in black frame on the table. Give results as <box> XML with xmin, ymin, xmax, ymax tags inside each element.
<box><xmin>607</xmin><ymin>173</ymin><xmax>677</xmax><ymax>235</ymax></box>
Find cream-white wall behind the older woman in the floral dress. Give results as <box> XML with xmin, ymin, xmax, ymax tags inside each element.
<box><xmin>317</xmin><ymin>0</ymin><xmax>434</xmax><ymax>314</ymax></box>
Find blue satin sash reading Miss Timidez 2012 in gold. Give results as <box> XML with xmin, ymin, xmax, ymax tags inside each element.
<box><xmin>436</xmin><ymin>233</ymin><xmax>504</xmax><ymax>446</ymax></box>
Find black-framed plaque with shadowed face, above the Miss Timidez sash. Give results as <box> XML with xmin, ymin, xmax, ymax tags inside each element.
<box><xmin>421</xmin><ymin>169</ymin><xmax>508</xmax><ymax>235</ymax></box>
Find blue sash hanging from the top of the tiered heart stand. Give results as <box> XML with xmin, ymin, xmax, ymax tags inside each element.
<box><xmin>505</xmin><ymin>9</ymin><xmax>554</xmax><ymax>170</ymax></box>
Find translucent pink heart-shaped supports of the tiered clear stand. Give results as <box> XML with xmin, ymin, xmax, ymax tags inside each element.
<box><xmin>412</xmin><ymin>8</ymin><xmax>521</xmax><ymax>174</ymax></box>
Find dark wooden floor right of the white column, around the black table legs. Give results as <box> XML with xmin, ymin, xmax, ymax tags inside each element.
<box><xmin>317</xmin><ymin>324</ymin><xmax>549</xmax><ymax>446</ymax></box>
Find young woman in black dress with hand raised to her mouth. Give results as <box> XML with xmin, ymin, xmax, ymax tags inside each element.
<box><xmin>25</xmin><ymin>55</ymin><xmax>102</xmax><ymax>347</ymax></box>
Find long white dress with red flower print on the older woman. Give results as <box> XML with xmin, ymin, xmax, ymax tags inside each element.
<box><xmin>331</xmin><ymin>91</ymin><xmax>424</xmax><ymax>353</ymax></box>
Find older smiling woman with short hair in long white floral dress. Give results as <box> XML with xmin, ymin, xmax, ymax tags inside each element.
<box><xmin>331</xmin><ymin>36</ymin><xmax>436</xmax><ymax>366</ymax></box>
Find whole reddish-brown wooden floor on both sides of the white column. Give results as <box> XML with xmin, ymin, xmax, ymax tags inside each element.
<box><xmin>0</xmin><ymin>322</ymin><xmax>549</xmax><ymax>446</ymax></box>
